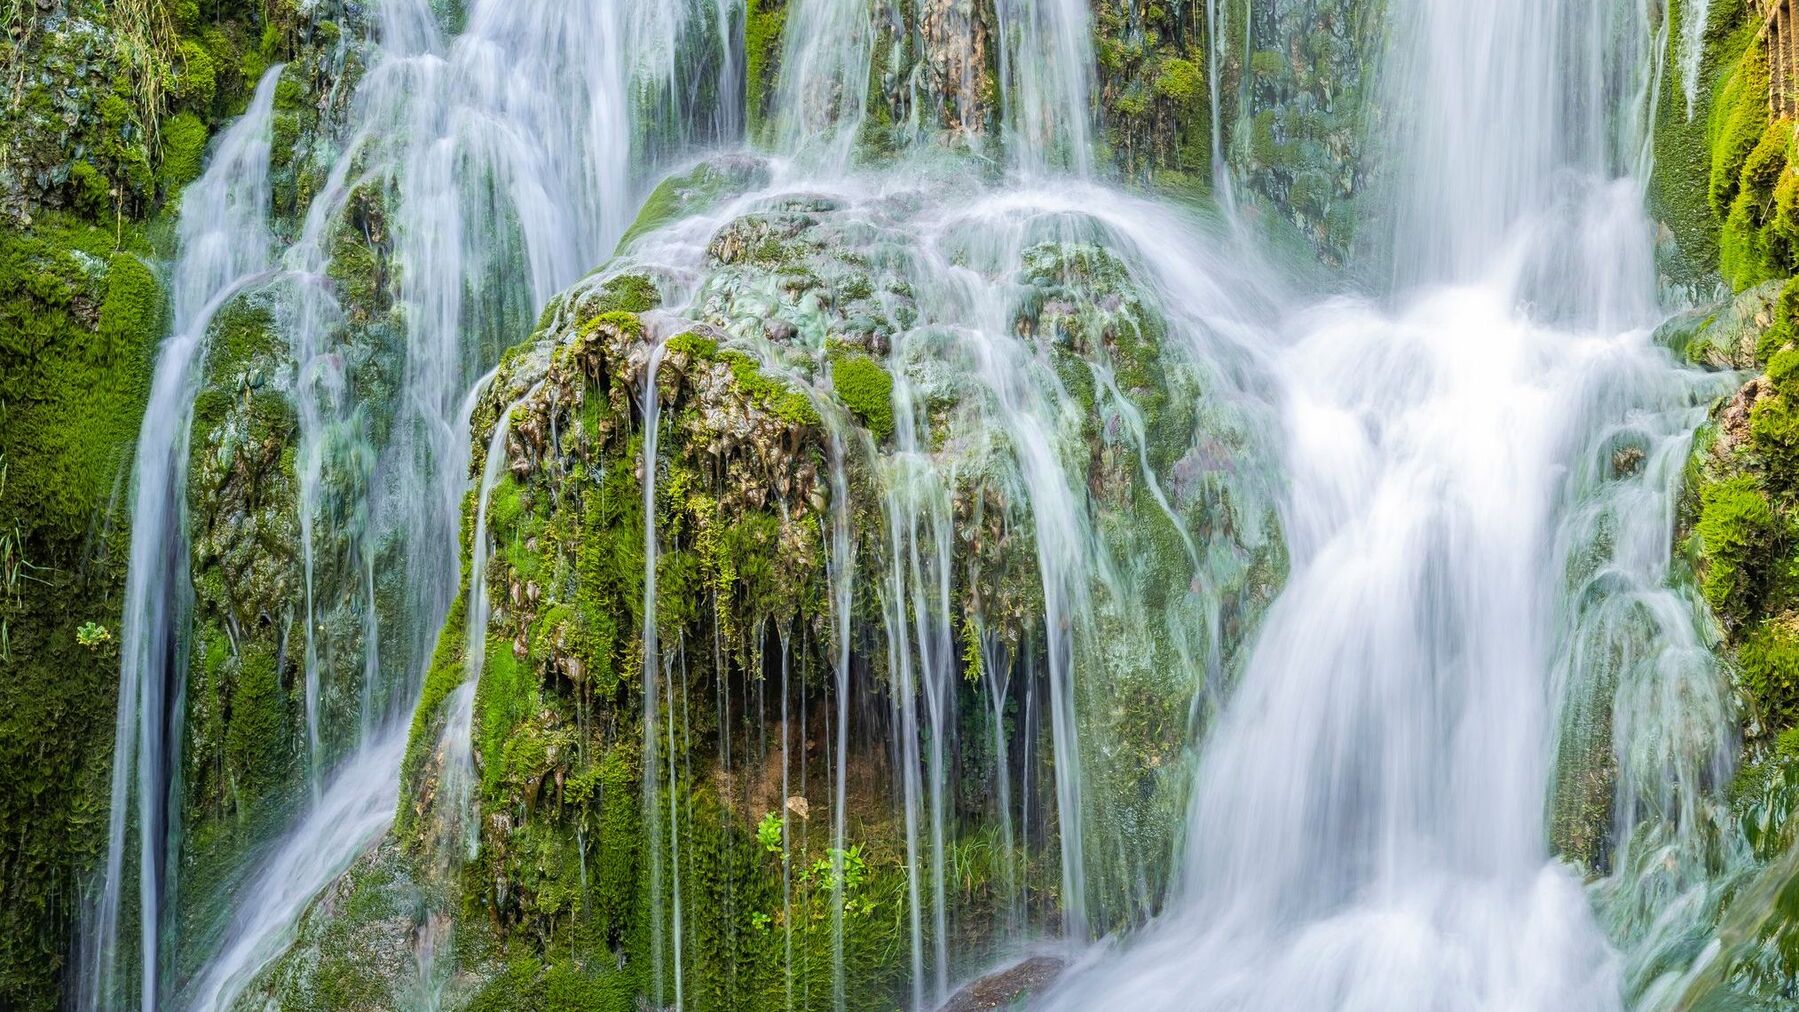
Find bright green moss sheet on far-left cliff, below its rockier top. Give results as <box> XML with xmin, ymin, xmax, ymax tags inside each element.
<box><xmin>0</xmin><ymin>212</ymin><xmax>162</xmax><ymax>1008</ymax></box>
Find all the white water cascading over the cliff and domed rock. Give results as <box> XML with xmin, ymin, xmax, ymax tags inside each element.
<box><xmin>83</xmin><ymin>0</ymin><xmax>1763</xmax><ymax>1012</ymax></box>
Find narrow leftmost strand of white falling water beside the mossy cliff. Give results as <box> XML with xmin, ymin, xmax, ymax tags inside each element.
<box><xmin>81</xmin><ymin>67</ymin><xmax>281</xmax><ymax>1012</ymax></box>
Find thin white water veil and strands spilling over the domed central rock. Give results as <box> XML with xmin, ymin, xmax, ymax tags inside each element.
<box><xmin>611</xmin><ymin>142</ymin><xmax>1270</xmax><ymax>1008</ymax></box>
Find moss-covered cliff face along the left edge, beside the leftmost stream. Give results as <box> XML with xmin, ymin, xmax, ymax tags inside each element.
<box><xmin>0</xmin><ymin>0</ymin><xmax>349</xmax><ymax>1008</ymax></box>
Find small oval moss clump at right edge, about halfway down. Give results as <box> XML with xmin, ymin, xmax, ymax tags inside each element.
<box><xmin>1696</xmin><ymin>476</ymin><xmax>1779</xmax><ymax>624</ymax></box>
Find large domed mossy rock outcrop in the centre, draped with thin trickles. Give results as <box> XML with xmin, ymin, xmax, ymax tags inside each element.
<box><xmin>340</xmin><ymin>156</ymin><xmax>1281</xmax><ymax>1007</ymax></box>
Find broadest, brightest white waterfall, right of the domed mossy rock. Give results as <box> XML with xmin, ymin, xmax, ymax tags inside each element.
<box><xmin>1051</xmin><ymin>0</ymin><xmax>1727</xmax><ymax>1008</ymax></box>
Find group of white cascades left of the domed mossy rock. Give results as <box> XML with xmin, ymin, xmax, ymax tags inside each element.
<box><xmin>83</xmin><ymin>0</ymin><xmax>741</xmax><ymax>1010</ymax></box>
